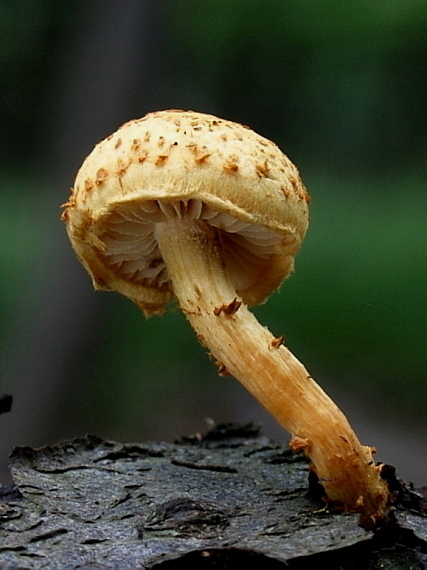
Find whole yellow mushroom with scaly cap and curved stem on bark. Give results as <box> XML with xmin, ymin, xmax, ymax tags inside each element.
<box><xmin>62</xmin><ymin>110</ymin><xmax>389</xmax><ymax>527</ymax></box>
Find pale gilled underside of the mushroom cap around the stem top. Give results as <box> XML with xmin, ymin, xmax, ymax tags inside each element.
<box><xmin>98</xmin><ymin>199</ymin><xmax>296</xmax><ymax>298</ymax></box>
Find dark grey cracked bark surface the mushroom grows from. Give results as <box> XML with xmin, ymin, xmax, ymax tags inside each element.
<box><xmin>0</xmin><ymin>425</ymin><xmax>427</xmax><ymax>570</ymax></box>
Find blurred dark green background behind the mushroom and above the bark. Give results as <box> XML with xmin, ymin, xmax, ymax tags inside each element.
<box><xmin>0</xmin><ymin>0</ymin><xmax>427</xmax><ymax>484</ymax></box>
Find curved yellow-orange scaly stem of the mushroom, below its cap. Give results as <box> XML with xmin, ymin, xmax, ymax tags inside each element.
<box><xmin>156</xmin><ymin>215</ymin><xmax>389</xmax><ymax>527</ymax></box>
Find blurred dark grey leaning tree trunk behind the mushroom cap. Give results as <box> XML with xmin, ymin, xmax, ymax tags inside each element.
<box><xmin>0</xmin><ymin>0</ymin><xmax>166</xmax><ymax>478</ymax></box>
